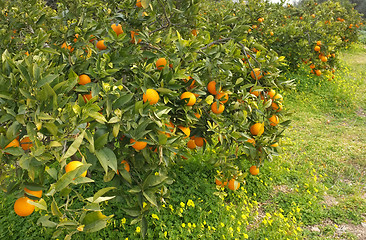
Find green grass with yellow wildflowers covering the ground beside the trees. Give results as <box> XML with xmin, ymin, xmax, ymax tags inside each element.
<box><xmin>0</xmin><ymin>45</ymin><xmax>366</xmax><ymax>240</ymax></box>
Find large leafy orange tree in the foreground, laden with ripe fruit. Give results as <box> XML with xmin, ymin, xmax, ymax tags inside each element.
<box><xmin>0</xmin><ymin>0</ymin><xmax>293</xmax><ymax>237</ymax></box>
